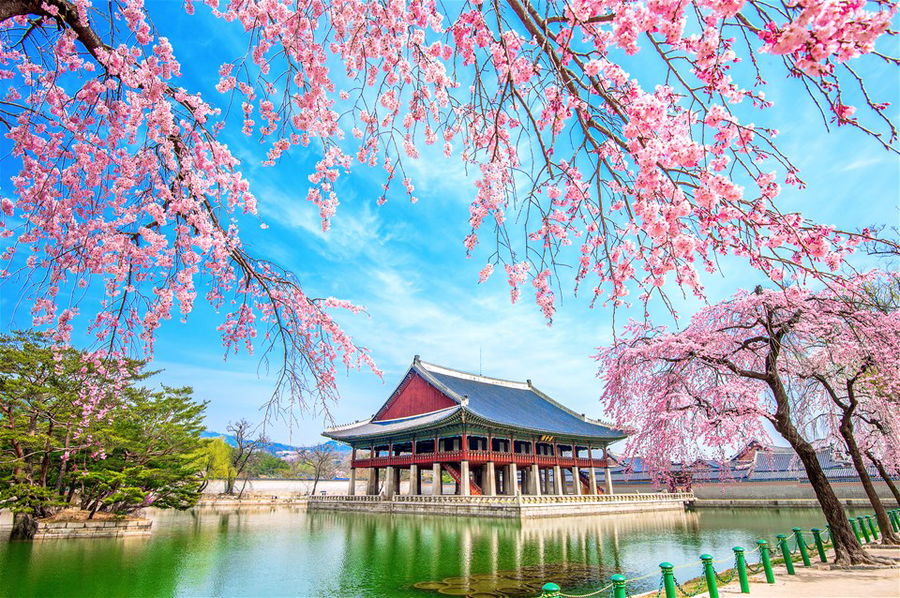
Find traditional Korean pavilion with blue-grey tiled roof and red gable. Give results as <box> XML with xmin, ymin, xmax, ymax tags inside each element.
<box><xmin>323</xmin><ymin>355</ymin><xmax>626</xmax><ymax>498</ymax></box>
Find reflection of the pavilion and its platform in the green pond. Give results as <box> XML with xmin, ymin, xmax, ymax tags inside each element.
<box><xmin>316</xmin><ymin>511</ymin><xmax>699</xmax><ymax>584</ymax></box>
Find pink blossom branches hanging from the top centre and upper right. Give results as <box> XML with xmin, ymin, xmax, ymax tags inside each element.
<box><xmin>204</xmin><ymin>0</ymin><xmax>898</xmax><ymax>319</ymax></box>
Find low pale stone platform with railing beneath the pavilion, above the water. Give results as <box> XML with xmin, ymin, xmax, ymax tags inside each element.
<box><xmin>307</xmin><ymin>492</ymin><xmax>694</xmax><ymax>519</ymax></box>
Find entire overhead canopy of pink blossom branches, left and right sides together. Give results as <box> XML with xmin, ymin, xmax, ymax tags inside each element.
<box><xmin>0</xmin><ymin>0</ymin><xmax>898</xmax><ymax>412</ymax></box>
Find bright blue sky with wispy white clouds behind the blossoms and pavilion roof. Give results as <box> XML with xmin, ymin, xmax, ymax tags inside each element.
<box><xmin>0</xmin><ymin>1</ymin><xmax>900</xmax><ymax>444</ymax></box>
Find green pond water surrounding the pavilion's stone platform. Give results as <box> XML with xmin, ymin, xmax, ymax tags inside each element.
<box><xmin>0</xmin><ymin>507</ymin><xmax>844</xmax><ymax>598</ymax></box>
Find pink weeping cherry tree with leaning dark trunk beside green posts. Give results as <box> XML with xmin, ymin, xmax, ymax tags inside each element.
<box><xmin>598</xmin><ymin>278</ymin><xmax>900</xmax><ymax>564</ymax></box>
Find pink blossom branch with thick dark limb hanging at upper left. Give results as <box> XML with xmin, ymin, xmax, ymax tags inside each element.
<box><xmin>0</xmin><ymin>0</ymin><xmax>377</xmax><ymax>418</ymax></box>
